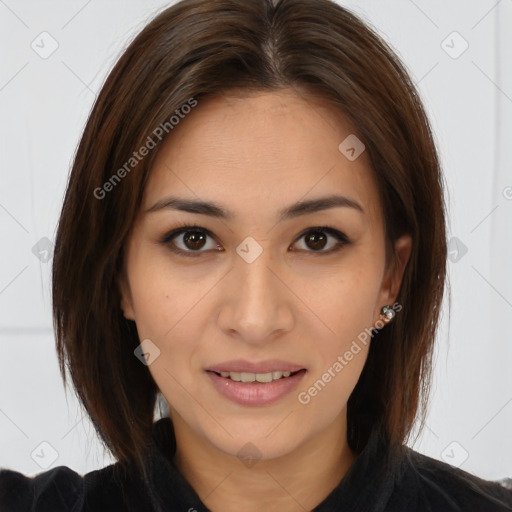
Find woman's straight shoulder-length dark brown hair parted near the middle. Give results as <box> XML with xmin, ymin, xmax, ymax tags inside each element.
<box><xmin>52</xmin><ymin>0</ymin><xmax>447</xmax><ymax>480</ymax></box>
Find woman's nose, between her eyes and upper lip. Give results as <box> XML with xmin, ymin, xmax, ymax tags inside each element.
<box><xmin>218</xmin><ymin>243</ymin><xmax>297</xmax><ymax>345</ymax></box>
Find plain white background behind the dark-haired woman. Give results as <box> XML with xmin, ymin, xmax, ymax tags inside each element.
<box><xmin>0</xmin><ymin>0</ymin><xmax>512</xmax><ymax>479</ymax></box>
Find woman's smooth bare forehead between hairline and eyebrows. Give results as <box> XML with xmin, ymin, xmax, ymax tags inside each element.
<box><xmin>143</xmin><ymin>90</ymin><xmax>380</xmax><ymax>224</ymax></box>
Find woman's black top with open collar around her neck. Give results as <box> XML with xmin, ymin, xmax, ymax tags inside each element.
<box><xmin>0</xmin><ymin>418</ymin><xmax>512</xmax><ymax>512</ymax></box>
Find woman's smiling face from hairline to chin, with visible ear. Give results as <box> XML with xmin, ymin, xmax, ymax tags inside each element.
<box><xmin>121</xmin><ymin>91</ymin><xmax>410</xmax><ymax>459</ymax></box>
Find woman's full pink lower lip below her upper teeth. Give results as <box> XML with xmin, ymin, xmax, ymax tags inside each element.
<box><xmin>206</xmin><ymin>370</ymin><xmax>306</xmax><ymax>406</ymax></box>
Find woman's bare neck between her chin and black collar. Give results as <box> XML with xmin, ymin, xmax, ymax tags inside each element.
<box><xmin>173</xmin><ymin>410</ymin><xmax>356</xmax><ymax>512</ymax></box>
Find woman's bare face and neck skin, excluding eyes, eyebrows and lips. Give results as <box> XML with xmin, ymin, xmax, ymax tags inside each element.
<box><xmin>120</xmin><ymin>90</ymin><xmax>411</xmax><ymax>512</ymax></box>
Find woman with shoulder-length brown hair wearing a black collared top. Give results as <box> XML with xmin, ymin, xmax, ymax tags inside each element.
<box><xmin>0</xmin><ymin>0</ymin><xmax>512</xmax><ymax>512</ymax></box>
